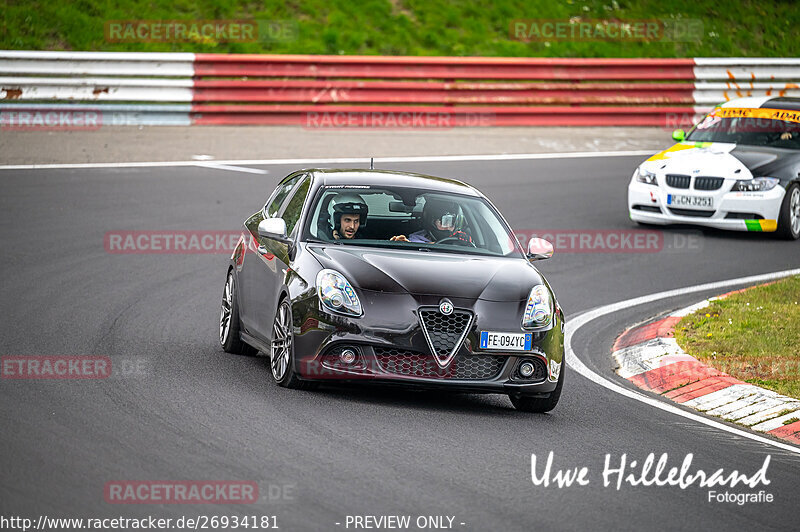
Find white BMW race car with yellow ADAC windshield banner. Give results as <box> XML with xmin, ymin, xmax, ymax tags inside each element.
<box><xmin>628</xmin><ymin>97</ymin><xmax>800</xmax><ymax>240</ymax></box>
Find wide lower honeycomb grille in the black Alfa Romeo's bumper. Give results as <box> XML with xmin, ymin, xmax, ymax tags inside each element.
<box><xmin>375</xmin><ymin>347</ymin><xmax>506</xmax><ymax>380</ymax></box>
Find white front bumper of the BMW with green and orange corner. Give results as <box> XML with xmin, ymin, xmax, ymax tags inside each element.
<box><xmin>628</xmin><ymin>179</ymin><xmax>786</xmax><ymax>232</ymax></box>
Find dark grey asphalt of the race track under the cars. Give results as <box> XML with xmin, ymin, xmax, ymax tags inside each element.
<box><xmin>0</xmin><ymin>157</ymin><xmax>800</xmax><ymax>531</ymax></box>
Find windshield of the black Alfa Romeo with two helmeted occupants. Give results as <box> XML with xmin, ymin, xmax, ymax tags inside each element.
<box><xmin>304</xmin><ymin>186</ymin><xmax>521</xmax><ymax>256</ymax></box>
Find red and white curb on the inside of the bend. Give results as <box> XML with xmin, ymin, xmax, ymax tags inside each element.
<box><xmin>613</xmin><ymin>290</ymin><xmax>800</xmax><ymax>444</ymax></box>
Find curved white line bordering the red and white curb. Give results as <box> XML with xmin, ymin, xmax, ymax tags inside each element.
<box><xmin>564</xmin><ymin>268</ymin><xmax>800</xmax><ymax>454</ymax></box>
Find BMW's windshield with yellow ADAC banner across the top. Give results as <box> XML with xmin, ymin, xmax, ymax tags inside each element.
<box><xmin>686</xmin><ymin>108</ymin><xmax>800</xmax><ymax>150</ymax></box>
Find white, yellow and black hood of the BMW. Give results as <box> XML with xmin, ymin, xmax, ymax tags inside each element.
<box><xmin>646</xmin><ymin>142</ymin><xmax>800</xmax><ymax>179</ymax></box>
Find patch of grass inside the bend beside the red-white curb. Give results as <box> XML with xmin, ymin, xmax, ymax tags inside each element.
<box><xmin>675</xmin><ymin>277</ymin><xmax>800</xmax><ymax>399</ymax></box>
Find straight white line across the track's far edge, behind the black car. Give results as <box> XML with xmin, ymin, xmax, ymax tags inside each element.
<box><xmin>0</xmin><ymin>149</ymin><xmax>658</xmax><ymax>170</ymax></box>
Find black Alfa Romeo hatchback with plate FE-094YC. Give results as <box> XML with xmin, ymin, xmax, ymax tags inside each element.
<box><xmin>219</xmin><ymin>170</ymin><xmax>564</xmax><ymax>412</ymax></box>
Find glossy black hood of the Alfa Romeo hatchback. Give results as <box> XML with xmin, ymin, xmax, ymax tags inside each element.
<box><xmin>309</xmin><ymin>246</ymin><xmax>544</xmax><ymax>301</ymax></box>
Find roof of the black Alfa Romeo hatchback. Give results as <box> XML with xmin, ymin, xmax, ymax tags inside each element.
<box><xmin>306</xmin><ymin>168</ymin><xmax>481</xmax><ymax>196</ymax></box>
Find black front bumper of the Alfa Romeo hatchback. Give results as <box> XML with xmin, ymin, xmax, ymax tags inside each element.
<box><xmin>293</xmin><ymin>292</ymin><xmax>564</xmax><ymax>397</ymax></box>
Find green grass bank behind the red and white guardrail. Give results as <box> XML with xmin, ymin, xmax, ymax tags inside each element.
<box><xmin>0</xmin><ymin>0</ymin><xmax>800</xmax><ymax>57</ymax></box>
